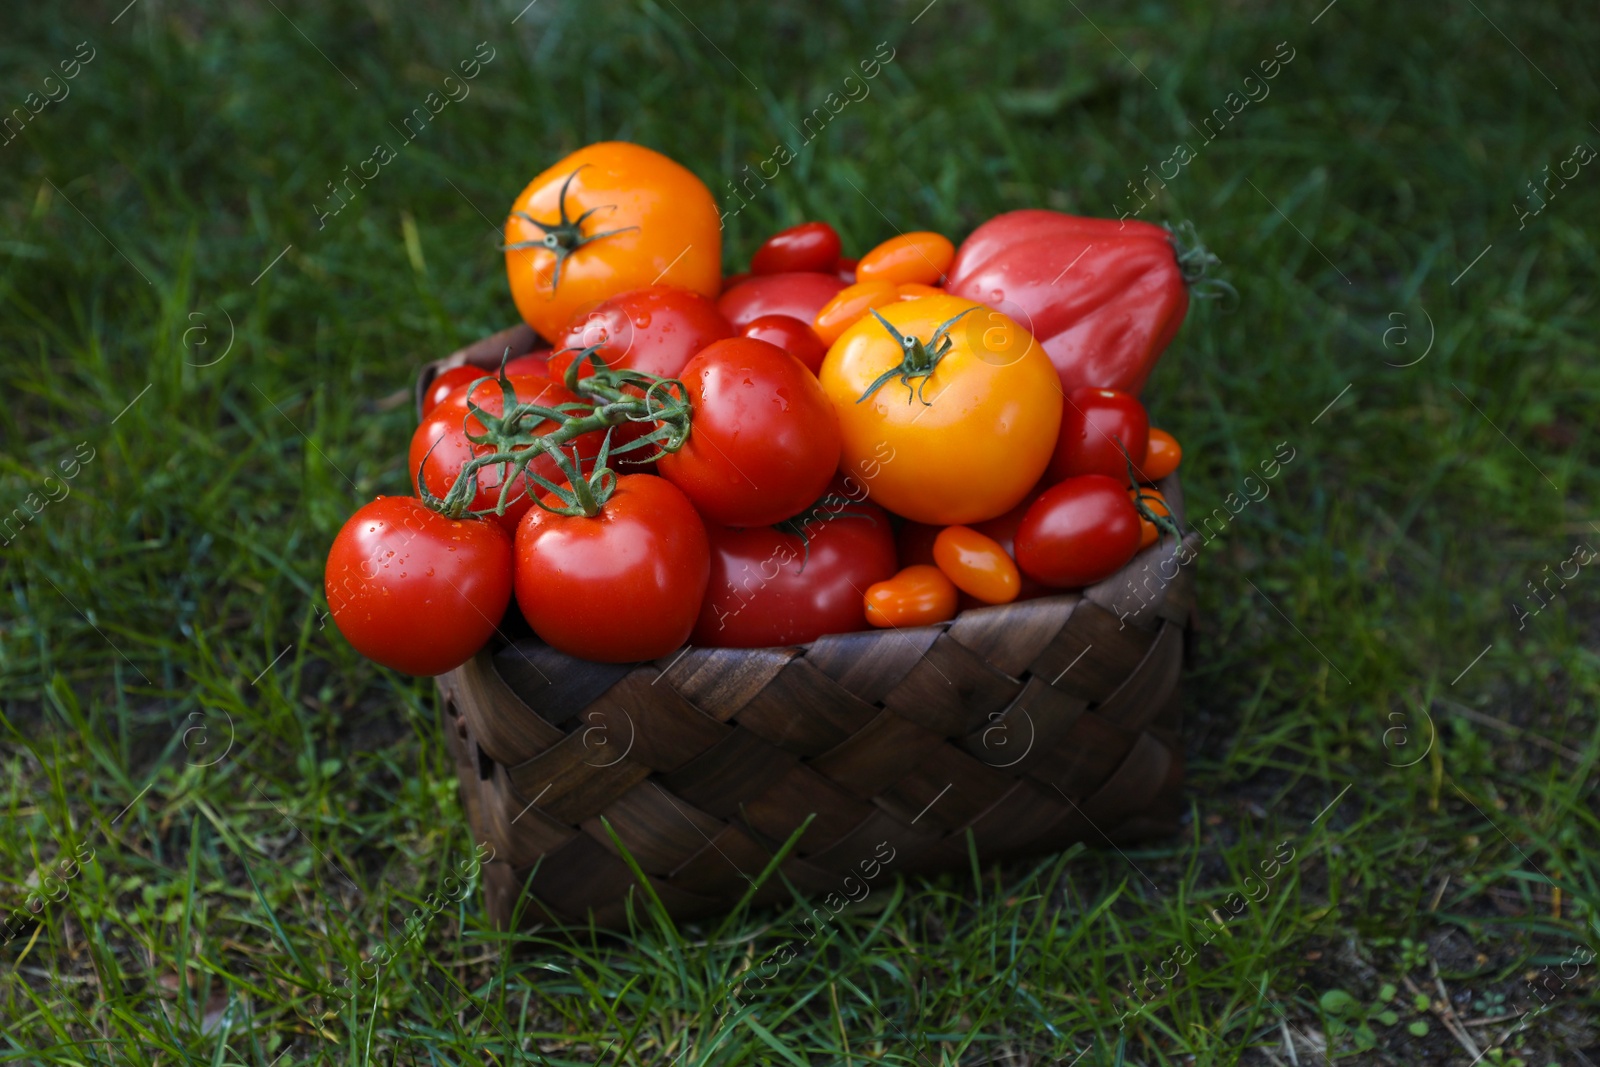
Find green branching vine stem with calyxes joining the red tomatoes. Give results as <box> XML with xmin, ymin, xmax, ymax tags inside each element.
<box><xmin>418</xmin><ymin>346</ymin><xmax>690</xmax><ymax>518</ymax></box>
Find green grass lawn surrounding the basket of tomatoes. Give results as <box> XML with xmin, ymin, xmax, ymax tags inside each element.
<box><xmin>0</xmin><ymin>0</ymin><xmax>1600</xmax><ymax>1067</ymax></box>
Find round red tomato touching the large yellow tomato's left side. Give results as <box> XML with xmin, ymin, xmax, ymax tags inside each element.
<box><xmin>656</xmin><ymin>338</ymin><xmax>838</xmax><ymax>526</ymax></box>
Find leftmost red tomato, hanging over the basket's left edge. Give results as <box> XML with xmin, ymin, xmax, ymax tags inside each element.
<box><xmin>323</xmin><ymin>496</ymin><xmax>512</xmax><ymax>675</ymax></box>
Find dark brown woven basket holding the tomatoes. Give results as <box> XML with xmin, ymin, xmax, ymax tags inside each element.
<box><xmin>419</xmin><ymin>326</ymin><xmax>1194</xmax><ymax>928</ymax></box>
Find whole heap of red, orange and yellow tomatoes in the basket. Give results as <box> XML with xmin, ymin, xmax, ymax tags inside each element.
<box><xmin>325</xmin><ymin>142</ymin><xmax>1205</xmax><ymax>675</ymax></box>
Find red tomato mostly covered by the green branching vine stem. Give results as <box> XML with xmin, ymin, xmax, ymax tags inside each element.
<box><xmin>406</xmin><ymin>376</ymin><xmax>601</xmax><ymax>533</ymax></box>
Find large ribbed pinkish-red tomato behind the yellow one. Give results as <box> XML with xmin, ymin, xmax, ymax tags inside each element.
<box><xmin>944</xmin><ymin>208</ymin><xmax>1196</xmax><ymax>395</ymax></box>
